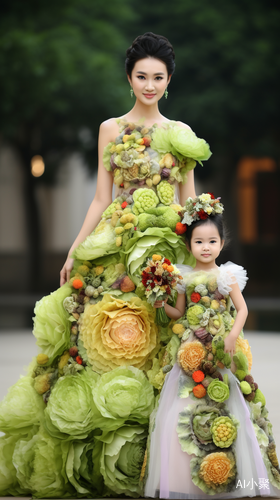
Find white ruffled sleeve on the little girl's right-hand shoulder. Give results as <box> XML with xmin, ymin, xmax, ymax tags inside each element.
<box><xmin>217</xmin><ymin>262</ymin><xmax>248</xmax><ymax>295</ymax></box>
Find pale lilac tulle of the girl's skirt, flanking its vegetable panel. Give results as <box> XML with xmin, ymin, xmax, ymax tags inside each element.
<box><xmin>145</xmin><ymin>364</ymin><xmax>280</xmax><ymax>499</ymax></box>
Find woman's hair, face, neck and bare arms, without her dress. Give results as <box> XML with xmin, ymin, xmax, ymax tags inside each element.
<box><xmin>60</xmin><ymin>33</ymin><xmax>199</xmax><ymax>285</ymax></box>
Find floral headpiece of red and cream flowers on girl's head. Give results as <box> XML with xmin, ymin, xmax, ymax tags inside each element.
<box><xmin>182</xmin><ymin>193</ymin><xmax>224</xmax><ymax>226</ymax></box>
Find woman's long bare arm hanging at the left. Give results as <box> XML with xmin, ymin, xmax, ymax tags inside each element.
<box><xmin>60</xmin><ymin>119</ymin><xmax>118</xmax><ymax>286</ymax></box>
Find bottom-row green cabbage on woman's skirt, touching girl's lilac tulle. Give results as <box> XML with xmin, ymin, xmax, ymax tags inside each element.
<box><xmin>100</xmin><ymin>426</ymin><xmax>147</xmax><ymax>497</ymax></box>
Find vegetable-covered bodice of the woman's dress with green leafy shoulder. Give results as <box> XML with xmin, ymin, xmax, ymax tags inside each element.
<box><xmin>103</xmin><ymin>120</ymin><xmax>211</xmax><ymax>204</ymax></box>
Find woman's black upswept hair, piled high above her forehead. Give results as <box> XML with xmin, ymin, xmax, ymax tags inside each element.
<box><xmin>125</xmin><ymin>31</ymin><xmax>175</xmax><ymax>77</ymax></box>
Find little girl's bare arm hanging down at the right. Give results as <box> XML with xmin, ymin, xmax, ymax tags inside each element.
<box><xmin>225</xmin><ymin>283</ymin><xmax>248</xmax><ymax>356</ymax></box>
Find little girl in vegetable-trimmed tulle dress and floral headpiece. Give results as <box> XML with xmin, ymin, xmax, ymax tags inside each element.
<box><xmin>145</xmin><ymin>194</ymin><xmax>280</xmax><ymax>499</ymax></box>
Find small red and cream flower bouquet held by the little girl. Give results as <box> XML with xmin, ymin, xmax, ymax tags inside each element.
<box><xmin>141</xmin><ymin>254</ymin><xmax>183</xmax><ymax>326</ymax></box>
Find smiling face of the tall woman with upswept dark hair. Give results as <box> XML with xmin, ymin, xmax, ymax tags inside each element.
<box><xmin>128</xmin><ymin>57</ymin><xmax>171</xmax><ymax>106</ymax></box>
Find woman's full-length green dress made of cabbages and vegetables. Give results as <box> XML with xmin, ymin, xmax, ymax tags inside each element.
<box><xmin>0</xmin><ymin>122</ymin><xmax>214</xmax><ymax>498</ymax></box>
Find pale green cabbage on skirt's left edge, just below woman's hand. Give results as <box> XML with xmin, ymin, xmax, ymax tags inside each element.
<box><xmin>33</xmin><ymin>283</ymin><xmax>72</xmax><ymax>364</ymax></box>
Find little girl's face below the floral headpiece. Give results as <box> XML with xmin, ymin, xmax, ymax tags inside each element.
<box><xmin>190</xmin><ymin>222</ymin><xmax>224</xmax><ymax>269</ymax></box>
